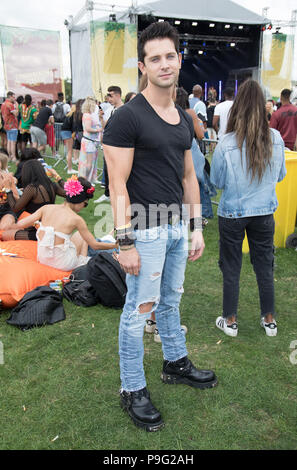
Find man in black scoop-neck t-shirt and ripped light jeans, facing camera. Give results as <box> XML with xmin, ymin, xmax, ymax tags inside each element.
<box><xmin>103</xmin><ymin>22</ymin><xmax>217</xmax><ymax>431</ymax></box>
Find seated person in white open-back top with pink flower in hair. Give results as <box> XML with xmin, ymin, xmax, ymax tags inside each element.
<box><xmin>8</xmin><ymin>176</ymin><xmax>117</xmax><ymax>271</ymax></box>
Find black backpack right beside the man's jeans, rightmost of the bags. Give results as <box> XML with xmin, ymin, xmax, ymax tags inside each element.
<box><xmin>87</xmin><ymin>252</ymin><xmax>127</xmax><ymax>308</ymax></box>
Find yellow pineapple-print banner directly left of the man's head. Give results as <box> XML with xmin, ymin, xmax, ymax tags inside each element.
<box><xmin>90</xmin><ymin>21</ymin><xmax>138</xmax><ymax>101</ymax></box>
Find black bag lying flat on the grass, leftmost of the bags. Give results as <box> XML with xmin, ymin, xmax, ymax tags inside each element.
<box><xmin>6</xmin><ymin>286</ymin><xmax>66</xmax><ymax>331</ymax></box>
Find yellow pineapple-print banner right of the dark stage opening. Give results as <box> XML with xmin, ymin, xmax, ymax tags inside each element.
<box><xmin>262</xmin><ymin>32</ymin><xmax>294</xmax><ymax>99</ymax></box>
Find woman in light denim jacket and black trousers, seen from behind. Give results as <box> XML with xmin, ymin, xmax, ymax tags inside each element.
<box><xmin>211</xmin><ymin>80</ymin><xmax>286</xmax><ymax>336</ymax></box>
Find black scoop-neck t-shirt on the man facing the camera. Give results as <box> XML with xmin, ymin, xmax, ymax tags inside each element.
<box><xmin>103</xmin><ymin>93</ymin><xmax>194</xmax><ymax>228</ymax></box>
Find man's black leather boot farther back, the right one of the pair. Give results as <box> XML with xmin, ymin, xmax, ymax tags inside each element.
<box><xmin>161</xmin><ymin>356</ymin><xmax>218</xmax><ymax>389</ymax></box>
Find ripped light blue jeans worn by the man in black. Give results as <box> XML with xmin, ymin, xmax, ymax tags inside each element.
<box><xmin>119</xmin><ymin>223</ymin><xmax>188</xmax><ymax>392</ymax></box>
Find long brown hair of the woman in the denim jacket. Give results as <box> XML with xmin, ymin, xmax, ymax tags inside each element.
<box><xmin>227</xmin><ymin>80</ymin><xmax>272</xmax><ymax>182</ymax></box>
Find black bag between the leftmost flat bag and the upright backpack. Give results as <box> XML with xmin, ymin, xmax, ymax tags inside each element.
<box><xmin>63</xmin><ymin>265</ymin><xmax>100</xmax><ymax>307</ymax></box>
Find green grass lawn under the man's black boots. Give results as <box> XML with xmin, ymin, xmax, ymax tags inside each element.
<box><xmin>0</xmin><ymin>152</ymin><xmax>297</xmax><ymax>450</ymax></box>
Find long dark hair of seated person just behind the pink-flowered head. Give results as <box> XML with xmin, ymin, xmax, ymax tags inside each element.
<box><xmin>22</xmin><ymin>160</ymin><xmax>55</xmax><ymax>203</ymax></box>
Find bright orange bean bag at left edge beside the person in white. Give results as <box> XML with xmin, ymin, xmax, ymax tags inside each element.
<box><xmin>0</xmin><ymin>240</ymin><xmax>71</xmax><ymax>308</ymax></box>
